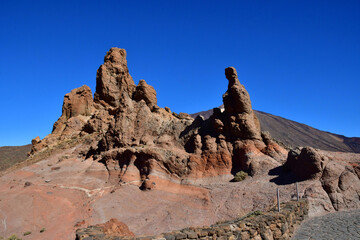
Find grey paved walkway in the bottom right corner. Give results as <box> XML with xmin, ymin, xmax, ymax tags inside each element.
<box><xmin>292</xmin><ymin>210</ymin><xmax>360</xmax><ymax>240</ymax></box>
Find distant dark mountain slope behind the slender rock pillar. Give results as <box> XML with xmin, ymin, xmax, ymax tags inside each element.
<box><xmin>190</xmin><ymin>109</ymin><xmax>360</xmax><ymax>153</ymax></box>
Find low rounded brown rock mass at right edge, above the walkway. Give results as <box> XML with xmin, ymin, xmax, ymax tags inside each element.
<box><xmin>284</xmin><ymin>147</ymin><xmax>360</xmax><ymax>210</ymax></box>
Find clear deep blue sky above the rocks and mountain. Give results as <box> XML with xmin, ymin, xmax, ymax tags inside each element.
<box><xmin>0</xmin><ymin>0</ymin><xmax>360</xmax><ymax>146</ymax></box>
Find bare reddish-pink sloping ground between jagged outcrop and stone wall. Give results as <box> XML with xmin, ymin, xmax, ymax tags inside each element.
<box><xmin>0</xmin><ymin>145</ymin><xmax>359</xmax><ymax>239</ymax></box>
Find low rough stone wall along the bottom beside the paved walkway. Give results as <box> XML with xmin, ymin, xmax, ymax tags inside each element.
<box><xmin>76</xmin><ymin>200</ymin><xmax>308</xmax><ymax>240</ymax></box>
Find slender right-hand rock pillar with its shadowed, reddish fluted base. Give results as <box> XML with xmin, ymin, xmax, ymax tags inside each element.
<box><xmin>184</xmin><ymin>67</ymin><xmax>287</xmax><ymax>176</ymax></box>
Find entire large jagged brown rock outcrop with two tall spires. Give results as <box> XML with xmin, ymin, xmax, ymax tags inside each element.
<box><xmin>32</xmin><ymin>48</ymin><xmax>287</xmax><ymax>190</ymax></box>
